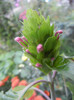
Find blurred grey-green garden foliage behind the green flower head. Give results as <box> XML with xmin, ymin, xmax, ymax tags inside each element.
<box><xmin>0</xmin><ymin>0</ymin><xmax>74</xmax><ymax>100</ymax></box>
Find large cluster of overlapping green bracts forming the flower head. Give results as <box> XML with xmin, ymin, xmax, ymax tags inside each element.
<box><xmin>22</xmin><ymin>9</ymin><xmax>68</xmax><ymax>74</ymax></box>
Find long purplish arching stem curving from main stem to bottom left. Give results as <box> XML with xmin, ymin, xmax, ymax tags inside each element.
<box><xmin>18</xmin><ymin>80</ymin><xmax>51</xmax><ymax>100</ymax></box>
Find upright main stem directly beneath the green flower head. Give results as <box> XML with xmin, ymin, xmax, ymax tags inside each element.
<box><xmin>48</xmin><ymin>73</ymin><xmax>56</xmax><ymax>100</ymax></box>
